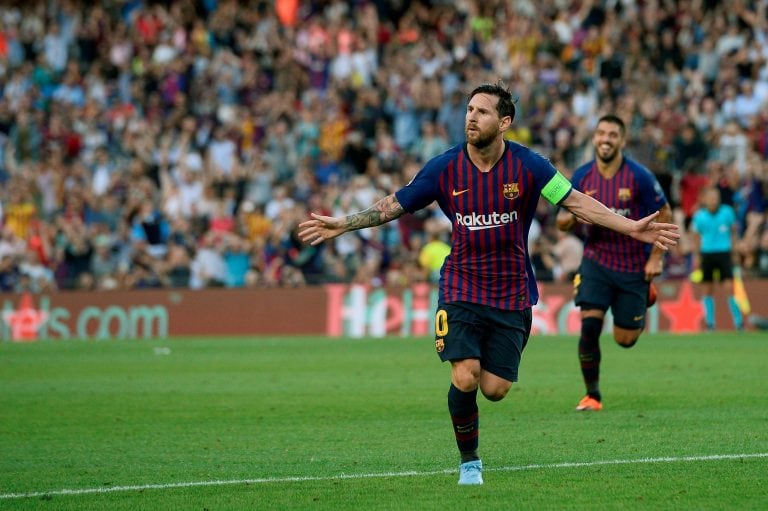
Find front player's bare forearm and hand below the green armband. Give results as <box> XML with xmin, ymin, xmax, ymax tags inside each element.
<box><xmin>562</xmin><ymin>190</ymin><xmax>680</xmax><ymax>250</ymax></box>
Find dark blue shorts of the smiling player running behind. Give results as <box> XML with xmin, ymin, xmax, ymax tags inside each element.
<box><xmin>573</xmin><ymin>259</ymin><xmax>650</xmax><ymax>330</ymax></box>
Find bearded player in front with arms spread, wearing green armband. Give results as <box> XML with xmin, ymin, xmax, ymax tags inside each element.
<box><xmin>299</xmin><ymin>84</ymin><xmax>679</xmax><ymax>484</ymax></box>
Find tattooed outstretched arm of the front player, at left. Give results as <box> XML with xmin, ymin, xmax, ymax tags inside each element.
<box><xmin>299</xmin><ymin>194</ymin><xmax>405</xmax><ymax>245</ymax></box>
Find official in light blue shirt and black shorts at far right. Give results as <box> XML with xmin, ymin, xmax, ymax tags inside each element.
<box><xmin>691</xmin><ymin>187</ymin><xmax>744</xmax><ymax>330</ymax></box>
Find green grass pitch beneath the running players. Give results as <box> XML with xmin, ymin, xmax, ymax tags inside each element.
<box><xmin>0</xmin><ymin>333</ymin><xmax>768</xmax><ymax>511</ymax></box>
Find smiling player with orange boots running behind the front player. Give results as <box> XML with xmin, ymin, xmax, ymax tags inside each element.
<box><xmin>556</xmin><ymin>115</ymin><xmax>672</xmax><ymax>411</ymax></box>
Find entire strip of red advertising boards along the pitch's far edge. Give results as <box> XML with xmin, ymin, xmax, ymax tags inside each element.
<box><xmin>0</xmin><ymin>280</ymin><xmax>768</xmax><ymax>342</ymax></box>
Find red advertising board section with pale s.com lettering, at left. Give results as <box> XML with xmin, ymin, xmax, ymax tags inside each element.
<box><xmin>0</xmin><ymin>288</ymin><xmax>326</xmax><ymax>341</ymax></box>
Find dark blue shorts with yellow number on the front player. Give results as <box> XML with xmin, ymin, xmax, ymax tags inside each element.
<box><xmin>435</xmin><ymin>302</ymin><xmax>532</xmax><ymax>381</ymax></box>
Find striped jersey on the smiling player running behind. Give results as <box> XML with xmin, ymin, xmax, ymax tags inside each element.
<box><xmin>571</xmin><ymin>156</ymin><xmax>667</xmax><ymax>272</ymax></box>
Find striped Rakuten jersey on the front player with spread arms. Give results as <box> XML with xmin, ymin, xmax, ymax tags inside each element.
<box><xmin>395</xmin><ymin>141</ymin><xmax>571</xmax><ymax>310</ymax></box>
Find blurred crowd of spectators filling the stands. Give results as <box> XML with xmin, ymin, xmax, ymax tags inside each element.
<box><xmin>0</xmin><ymin>0</ymin><xmax>768</xmax><ymax>292</ymax></box>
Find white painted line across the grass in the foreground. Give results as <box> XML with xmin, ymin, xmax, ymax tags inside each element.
<box><xmin>0</xmin><ymin>452</ymin><xmax>768</xmax><ymax>500</ymax></box>
